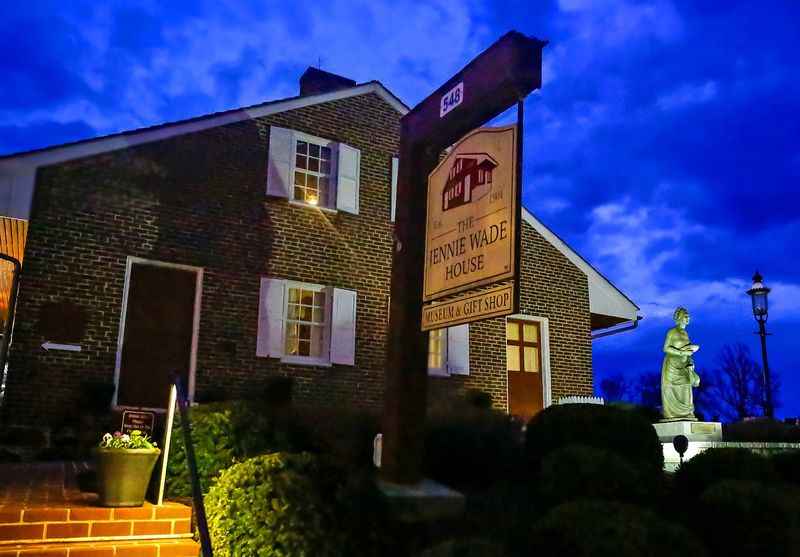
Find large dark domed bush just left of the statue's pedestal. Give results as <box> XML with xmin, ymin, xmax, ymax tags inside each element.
<box><xmin>525</xmin><ymin>404</ymin><xmax>664</xmax><ymax>475</ymax></box>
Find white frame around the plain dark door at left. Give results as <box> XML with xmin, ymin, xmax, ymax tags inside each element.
<box><xmin>111</xmin><ymin>255</ymin><xmax>203</xmax><ymax>414</ymax></box>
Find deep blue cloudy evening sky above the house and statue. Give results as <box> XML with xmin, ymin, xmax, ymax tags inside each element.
<box><xmin>0</xmin><ymin>0</ymin><xmax>800</xmax><ymax>415</ymax></box>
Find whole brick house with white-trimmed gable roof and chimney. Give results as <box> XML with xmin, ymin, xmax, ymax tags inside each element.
<box><xmin>0</xmin><ymin>69</ymin><xmax>638</xmax><ymax>425</ymax></box>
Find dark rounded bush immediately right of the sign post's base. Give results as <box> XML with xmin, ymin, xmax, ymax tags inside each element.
<box><xmin>423</xmin><ymin>406</ymin><xmax>521</xmax><ymax>489</ymax></box>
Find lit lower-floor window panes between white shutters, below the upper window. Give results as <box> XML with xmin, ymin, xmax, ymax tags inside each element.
<box><xmin>285</xmin><ymin>285</ymin><xmax>327</xmax><ymax>358</ymax></box>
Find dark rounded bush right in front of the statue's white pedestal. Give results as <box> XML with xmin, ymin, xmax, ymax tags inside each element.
<box><xmin>674</xmin><ymin>448</ymin><xmax>778</xmax><ymax>497</ymax></box>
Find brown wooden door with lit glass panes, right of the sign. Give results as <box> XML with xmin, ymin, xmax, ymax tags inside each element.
<box><xmin>506</xmin><ymin>319</ymin><xmax>544</xmax><ymax>420</ymax></box>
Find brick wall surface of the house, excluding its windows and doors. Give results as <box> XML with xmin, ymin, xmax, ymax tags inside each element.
<box><xmin>4</xmin><ymin>94</ymin><xmax>592</xmax><ymax>425</ymax></box>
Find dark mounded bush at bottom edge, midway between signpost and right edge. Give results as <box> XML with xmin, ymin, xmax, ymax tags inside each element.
<box><xmin>514</xmin><ymin>500</ymin><xmax>706</xmax><ymax>557</ymax></box>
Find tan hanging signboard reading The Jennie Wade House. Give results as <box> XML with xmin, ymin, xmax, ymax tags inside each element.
<box><xmin>423</xmin><ymin>126</ymin><xmax>518</xmax><ymax>302</ymax></box>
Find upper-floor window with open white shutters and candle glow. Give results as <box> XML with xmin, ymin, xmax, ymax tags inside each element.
<box><xmin>267</xmin><ymin>126</ymin><xmax>361</xmax><ymax>214</ymax></box>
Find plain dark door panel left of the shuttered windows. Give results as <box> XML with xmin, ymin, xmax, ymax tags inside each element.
<box><xmin>117</xmin><ymin>263</ymin><xmax>197</xmax><ymax>408</ymax></box>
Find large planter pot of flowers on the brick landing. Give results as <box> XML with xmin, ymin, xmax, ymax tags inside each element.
<box><xmin>95</xmin><ymin>430</ymin><xmax>161</xmax><ymax>507</ymax></box>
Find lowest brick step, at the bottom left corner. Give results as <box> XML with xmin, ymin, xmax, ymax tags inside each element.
<box><xmin>0</xmin><ymin>539</ymin><xmax>200</xmax><ymax>557</ymax></box>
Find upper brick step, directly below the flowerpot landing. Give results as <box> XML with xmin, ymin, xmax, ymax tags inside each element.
<box><xmin>0</xmin><ymin>502</ymin><xmax>192</xmax><ymax>548</ymax></box>
